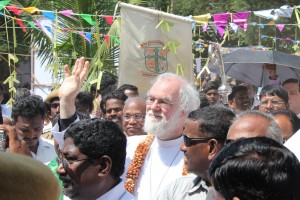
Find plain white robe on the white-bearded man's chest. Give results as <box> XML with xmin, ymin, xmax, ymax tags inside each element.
<box><xmin>126</xmin><ymin>137</ymin><xmax>184</xmax><ymax>200</ymax></box>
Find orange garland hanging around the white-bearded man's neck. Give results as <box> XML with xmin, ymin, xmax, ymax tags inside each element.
<box><xmin>124</xmin><ymin>135</ymin><xmax>188</xmax><ymax>194</ymax></box>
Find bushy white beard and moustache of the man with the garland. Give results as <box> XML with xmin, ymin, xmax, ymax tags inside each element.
<box><xmin>144</xmin><ymin>110</ymin><xmax>181</xmax><ymax>138</ymax></box>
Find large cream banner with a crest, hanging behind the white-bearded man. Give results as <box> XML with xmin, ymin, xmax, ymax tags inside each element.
<box><xmin>119</xmin><ymin>3</ymin><xmax>194</xmax><ymax>95</ymax></box>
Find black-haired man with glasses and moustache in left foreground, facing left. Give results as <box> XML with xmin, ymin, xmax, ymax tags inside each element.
<box><xmin>56</xmin><ymin>118</ymin><xmax>134</xmax><ymax>200</ymax></box>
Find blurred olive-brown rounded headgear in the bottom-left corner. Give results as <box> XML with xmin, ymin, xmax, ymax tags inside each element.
<box><xmin>0</xmin><ymin>153</ymin><xmax>61</xmax><ymax>200</ymax></box>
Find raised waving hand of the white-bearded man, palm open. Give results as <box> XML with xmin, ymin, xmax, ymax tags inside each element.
<box><xmin>58</xmin><ymin>57</ymin><xmax>89</xmax><ymax>119</ymax></box>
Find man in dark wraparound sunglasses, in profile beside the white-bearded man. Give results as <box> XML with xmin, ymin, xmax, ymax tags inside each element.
<box><xmin>155</xmin><ymin>105</ymin><xmax>235</xmax><ymax>200</ymax></box>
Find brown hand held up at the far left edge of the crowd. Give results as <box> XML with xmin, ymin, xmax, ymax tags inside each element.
<box><xmin>0</xmin><ymin>125</ymin><xmax>32</xmax><ymax>157</ymax></box>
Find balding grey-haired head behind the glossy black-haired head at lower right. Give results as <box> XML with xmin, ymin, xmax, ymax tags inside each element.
<box><xmin>227</xmin><ymin>110</ymin><xmax>283</xmax><ymax>144</ymax></box>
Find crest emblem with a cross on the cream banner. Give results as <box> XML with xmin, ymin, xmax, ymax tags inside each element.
<box><xmin>141</xmin><ymin>40</ymin><xmax>168</xmax><ymax>76</ymax></box>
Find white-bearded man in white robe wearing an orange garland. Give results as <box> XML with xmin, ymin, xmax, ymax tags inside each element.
<box><xmin>125</xmin><ymin>73</ymin><xmax>200</xmax><ymax>200</ymax></box>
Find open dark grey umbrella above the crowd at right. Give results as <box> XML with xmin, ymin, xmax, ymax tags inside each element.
<box><xmin>209</xmin><ymin>49</ymin><xmax>300</xmax><ymax>86</ymax></box>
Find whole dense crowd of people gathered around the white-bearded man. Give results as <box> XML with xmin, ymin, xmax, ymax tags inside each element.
<box><xmin>0</xmin><ymin>57</ymin><xmax>300</xmax><ymax>200</ymax></box>
